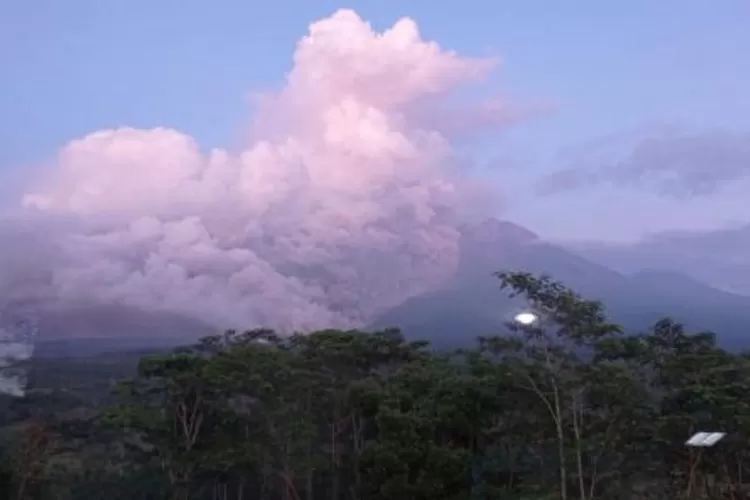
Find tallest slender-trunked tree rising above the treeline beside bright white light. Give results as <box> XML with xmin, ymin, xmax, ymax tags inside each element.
<box><xmin>494</xmin><ymin>273</ymin><xmax>621</xmax><ymax>500</ymax></box>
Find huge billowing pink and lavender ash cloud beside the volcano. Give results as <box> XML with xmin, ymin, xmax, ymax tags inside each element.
<box><xmin>0</xmin><ymin>10</ymin><xmax>515</xmax><ymax>352</ymax></box>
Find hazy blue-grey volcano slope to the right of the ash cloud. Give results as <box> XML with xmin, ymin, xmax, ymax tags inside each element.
<box><xmin>374</xmin><ymin>220</ymin><xmax>750</xmax><ymax>347</ymax></box>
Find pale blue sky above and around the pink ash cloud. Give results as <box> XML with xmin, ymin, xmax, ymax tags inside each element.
<box><xmin>0</xmin><ymin>0</ymin><xmax>750</xmax><ymax>239</ymax></box>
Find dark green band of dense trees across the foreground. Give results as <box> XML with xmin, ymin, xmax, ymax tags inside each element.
<box><xmin>0</xmin><ymin>273</ymin><xmax>750</xmax><ymax>500</ymax></box>
